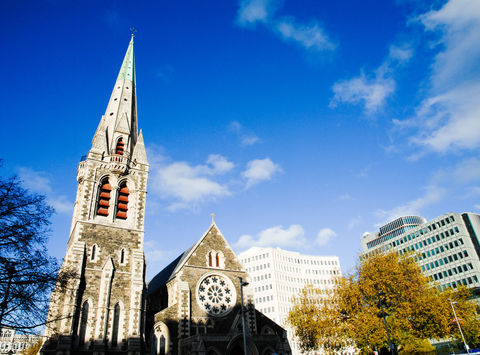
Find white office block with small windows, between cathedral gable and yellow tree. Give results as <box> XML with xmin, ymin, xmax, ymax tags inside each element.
<box><xmin>238</xmin><ymin>247</ymin><xmax>341</xmax><ymax>354</ymax></box>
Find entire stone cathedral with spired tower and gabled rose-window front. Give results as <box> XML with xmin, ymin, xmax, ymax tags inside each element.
<box><xmin>41</xmin><ymin>35</ymin><xmax>291</xmax><ymax>355</ymax></box>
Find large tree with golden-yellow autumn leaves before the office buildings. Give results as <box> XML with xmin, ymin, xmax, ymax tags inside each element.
<box><xmin>287</xmin><ymin>252</ymin><xmax>480</xmax><ymax>353</ymax></box>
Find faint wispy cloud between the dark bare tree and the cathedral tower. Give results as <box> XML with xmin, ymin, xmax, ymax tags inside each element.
<box><xmin>18</xmin><ymin>167</ymin><xmax>73</xmax><ymax>214</ymax></box>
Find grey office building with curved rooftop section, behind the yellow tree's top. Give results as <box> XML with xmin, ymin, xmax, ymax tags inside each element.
<box><xmin>360</xmin><ymin>212</ymin><xmax>480</xmax><ymax>297</ymax></box>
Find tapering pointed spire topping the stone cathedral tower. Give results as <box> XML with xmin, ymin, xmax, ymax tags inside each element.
<box><xmin>91</xmin><ymin>34</ymin><xmax>138</xmax><ymax>158</ymax></box>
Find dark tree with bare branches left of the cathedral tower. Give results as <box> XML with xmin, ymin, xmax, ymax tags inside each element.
<box><xmin>0</xmin><ymin>168</ymin><xmax>71</xmax><ymax>330</ymax></box>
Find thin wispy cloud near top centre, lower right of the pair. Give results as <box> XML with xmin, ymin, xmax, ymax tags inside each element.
<box><xmin>276</xmin><ymin>18</ymin><xmax>335</xmax><ymax>51</ymax></box>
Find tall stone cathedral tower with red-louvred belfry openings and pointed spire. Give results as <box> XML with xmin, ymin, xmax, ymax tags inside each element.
<box><xmin>42</xmin><ymin>35</ymin><xmax>148</xmax><ymax>354</ymax></box>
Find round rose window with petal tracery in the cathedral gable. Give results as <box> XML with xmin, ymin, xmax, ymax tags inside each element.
<box><xmin>197</xmin><ymin>275</ymin><xmax>236</xmax><ymax>316</ymax></box>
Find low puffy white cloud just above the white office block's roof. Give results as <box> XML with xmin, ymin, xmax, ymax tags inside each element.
<box><xmin>235</xmin><ymin>224</ymin><xmax>306</xmax><ymax>249</ymax></box>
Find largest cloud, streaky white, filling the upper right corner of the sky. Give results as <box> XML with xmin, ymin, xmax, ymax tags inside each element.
<box><xmin>397</xmin><ymin>0</ymin><xmax>480</xmax><ymax>157</ymax></box>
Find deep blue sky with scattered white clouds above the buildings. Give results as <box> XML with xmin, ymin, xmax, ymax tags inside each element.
<box><xmin>0</xmin><ymin>0</ymin><xmax>480</xmax><ymax>278</ymax></box>
